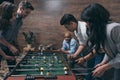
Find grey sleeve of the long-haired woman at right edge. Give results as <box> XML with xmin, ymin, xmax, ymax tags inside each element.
<box><xmin>108</xmin><ymin>26</ymin><xmax>120</xmax><ymax>68</ymax></box>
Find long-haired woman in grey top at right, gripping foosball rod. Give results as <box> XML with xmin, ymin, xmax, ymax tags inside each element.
<box><xmin>81</xmin><ymin>3</ymin><xmax>120</xmax><ymax>80</ymax></box>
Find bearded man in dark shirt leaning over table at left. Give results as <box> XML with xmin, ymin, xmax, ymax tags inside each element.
<box><xmin>1</xmin><ymin>1</ymin><xmax>34</xmax><ymax>70</ymax></box>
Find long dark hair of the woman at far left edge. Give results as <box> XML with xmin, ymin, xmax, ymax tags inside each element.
<box><xmin>0</xmin><ymin>1</ymin><xmax>17</xmax><ymax>21</ymax></box>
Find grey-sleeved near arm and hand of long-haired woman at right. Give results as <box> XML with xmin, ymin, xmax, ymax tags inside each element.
<box><xmin>93</xmin><ymin>26</ymin><xmax>120</xmax><ymax>77</ymax></box>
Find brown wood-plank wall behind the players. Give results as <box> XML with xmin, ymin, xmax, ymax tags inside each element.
<box><xmin>18</xmin><ymin>0</ymin><xmax>120</xmax><ymax>49</ymax></box>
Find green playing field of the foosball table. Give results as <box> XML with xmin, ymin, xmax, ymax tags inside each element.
<box><xmin>12</xmin><ymin>52</ymin><xmax>69</xmax><ymax>76</ymax></box>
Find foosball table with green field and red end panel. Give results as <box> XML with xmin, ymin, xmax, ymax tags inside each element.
<box><xmin>5</xmin><ymin>51</ymin><xmax>76</xmax><ymax>80</ymax></box>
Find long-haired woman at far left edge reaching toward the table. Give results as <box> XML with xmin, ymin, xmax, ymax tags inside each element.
<box><xmin>0</xmin><ymin>1</ymin><xmax>17</xmax><ymax>62</ymax></box>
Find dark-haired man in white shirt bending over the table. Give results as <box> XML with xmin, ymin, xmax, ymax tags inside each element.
<box><xmin>60</xmin><ymin>14</ymin><xmax>94</xmax><ymax>80</ymax></box>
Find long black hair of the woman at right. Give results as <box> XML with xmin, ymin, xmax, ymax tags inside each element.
<box><xmin>81</xmin><ymin>3</ymin><xmax>110</xmax><ymax>50</ymax></box>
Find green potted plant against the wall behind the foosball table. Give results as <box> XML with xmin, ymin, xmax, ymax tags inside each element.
<box><xmin>22</xmin><ymin>31</ymin><xmax>33</xmax><ymax>48</ymax></box>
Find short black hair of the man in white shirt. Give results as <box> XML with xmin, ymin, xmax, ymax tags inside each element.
<box><xmin>60</xmin><ymin>14</ymin><xmax>77</xmax><ymax>25</ymax></box>
